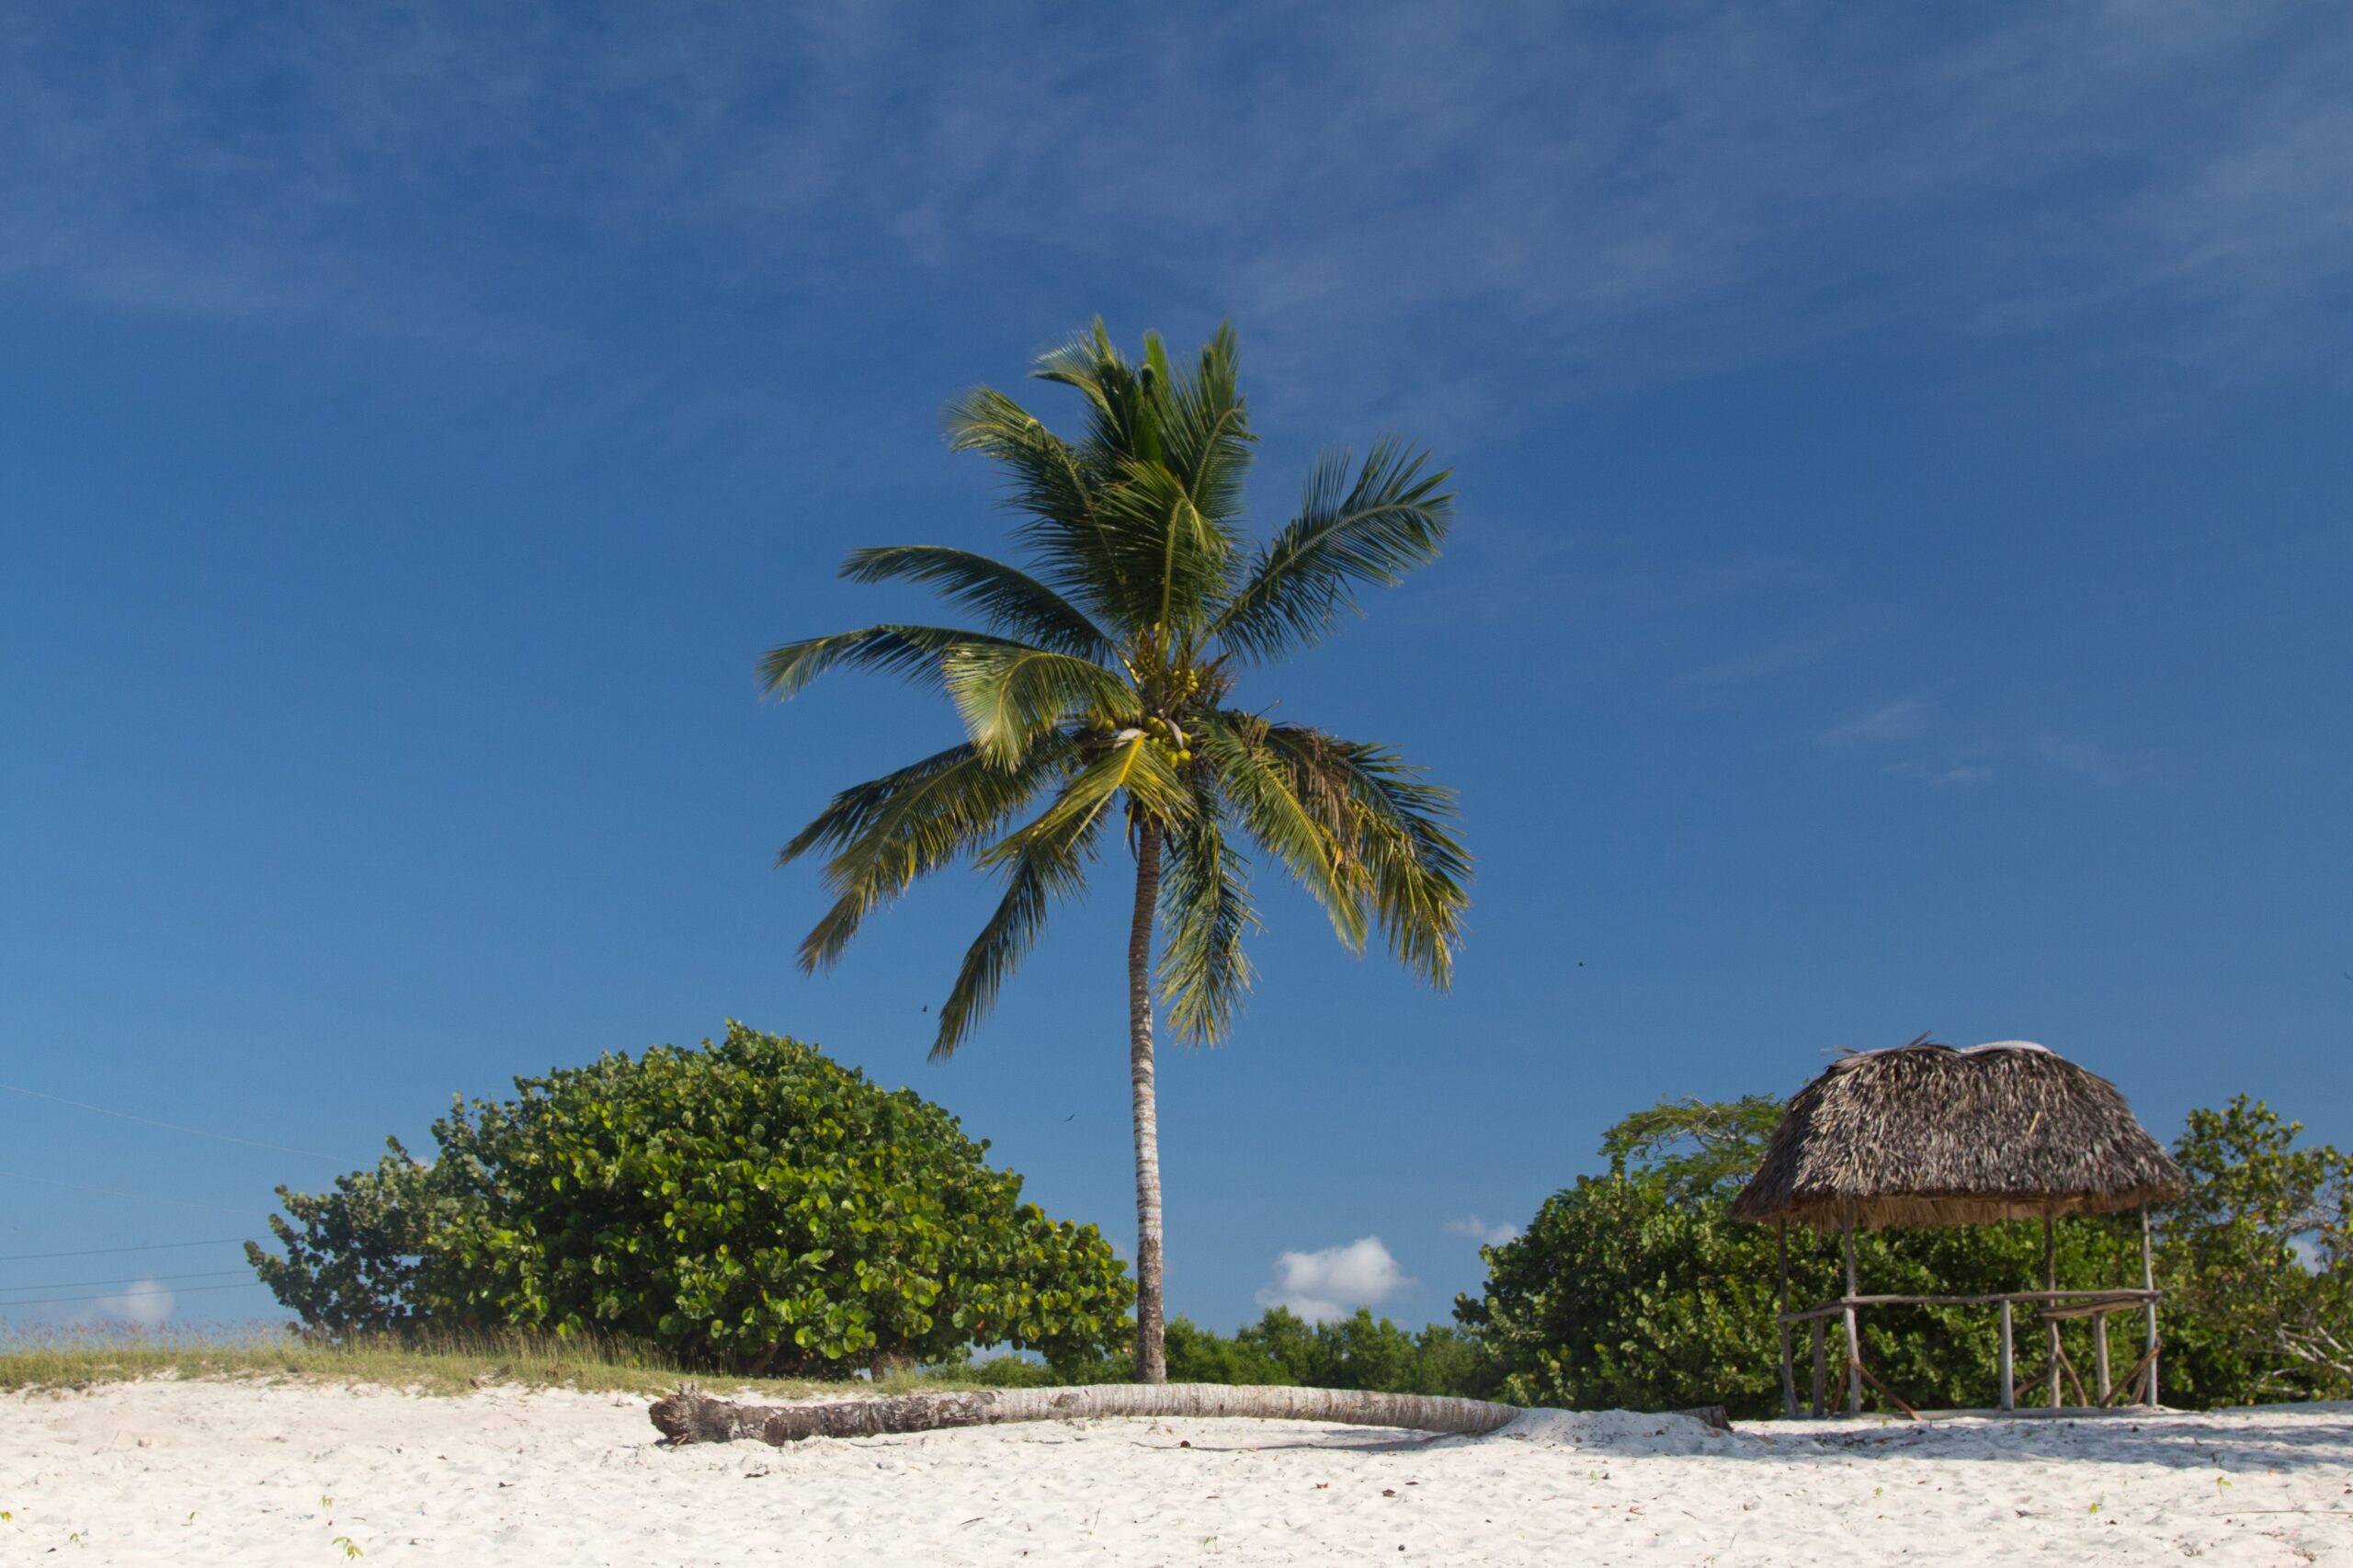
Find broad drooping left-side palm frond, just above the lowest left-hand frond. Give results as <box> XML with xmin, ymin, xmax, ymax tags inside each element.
<box><xmin>777</xmin><ymin>734</ymin><xmax>1071</xmax><ymax>972</ymax></box>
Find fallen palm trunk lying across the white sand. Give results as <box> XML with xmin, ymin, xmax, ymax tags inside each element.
<box><xmin>652</xmin><ymin>1382</ymin><xmax>1732</xmax><ymax>1446</ymax></box>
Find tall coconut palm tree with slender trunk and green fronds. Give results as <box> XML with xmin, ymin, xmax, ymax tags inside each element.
<box><xmin>760</xmin><ymin>320</ymin><xmax>1471</xmax><ymax>1382</ymax></box>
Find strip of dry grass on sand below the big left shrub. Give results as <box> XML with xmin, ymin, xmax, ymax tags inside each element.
<box><xmin>0</xmin><ymin>1325</ymin><xmax>976</xmax><ymax>1399</ymax></box>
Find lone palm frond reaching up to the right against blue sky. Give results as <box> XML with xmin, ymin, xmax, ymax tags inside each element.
<box><xmin>1214</xmin><ymin>436</ymin><xmax>1454</xmax><ymax>659</ymax></box>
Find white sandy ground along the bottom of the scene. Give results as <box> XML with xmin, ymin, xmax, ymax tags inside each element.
<box><xmin>0</xmin><ymin>1382</ymin><xmax>2353</xmax><ymax>1568</ymax></box>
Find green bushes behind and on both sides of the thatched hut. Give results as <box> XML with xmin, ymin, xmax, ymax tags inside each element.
<box><xmin>1454</xmin><ymin>1095</ymin><xmax>2353</xmax><ymax>1415</ymax></box>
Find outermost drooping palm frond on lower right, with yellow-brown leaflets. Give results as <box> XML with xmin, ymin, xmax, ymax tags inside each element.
<box><xmin>1266</xmin><ymin>725</ymin><xmax>1471</xmax><ymax>991</ymax></box>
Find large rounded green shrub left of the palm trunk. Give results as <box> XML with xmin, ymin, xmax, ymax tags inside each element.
<box><xmin>256</xmin><ymin>1024</ymin><xmax>1134</xmax><ymax>1378</ymax></box>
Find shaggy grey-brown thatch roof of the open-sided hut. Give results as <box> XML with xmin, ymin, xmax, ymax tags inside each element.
<box><xmin>1732</xmin><ymin>1040</ymin><xmax>2184</xmax><ymax>1229</ymax></box>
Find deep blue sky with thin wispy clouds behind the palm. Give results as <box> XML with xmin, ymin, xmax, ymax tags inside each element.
<box><xmin>0</xmin><ymin>3</ymin><xmax>2353</xmax><ymax>1325</ymax></box>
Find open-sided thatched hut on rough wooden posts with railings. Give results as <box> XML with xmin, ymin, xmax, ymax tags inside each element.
<box><xmin>1732</xmin><ymin>1036</ymin><xmax>2186</xmax><ymax>1415</ymax></box>
